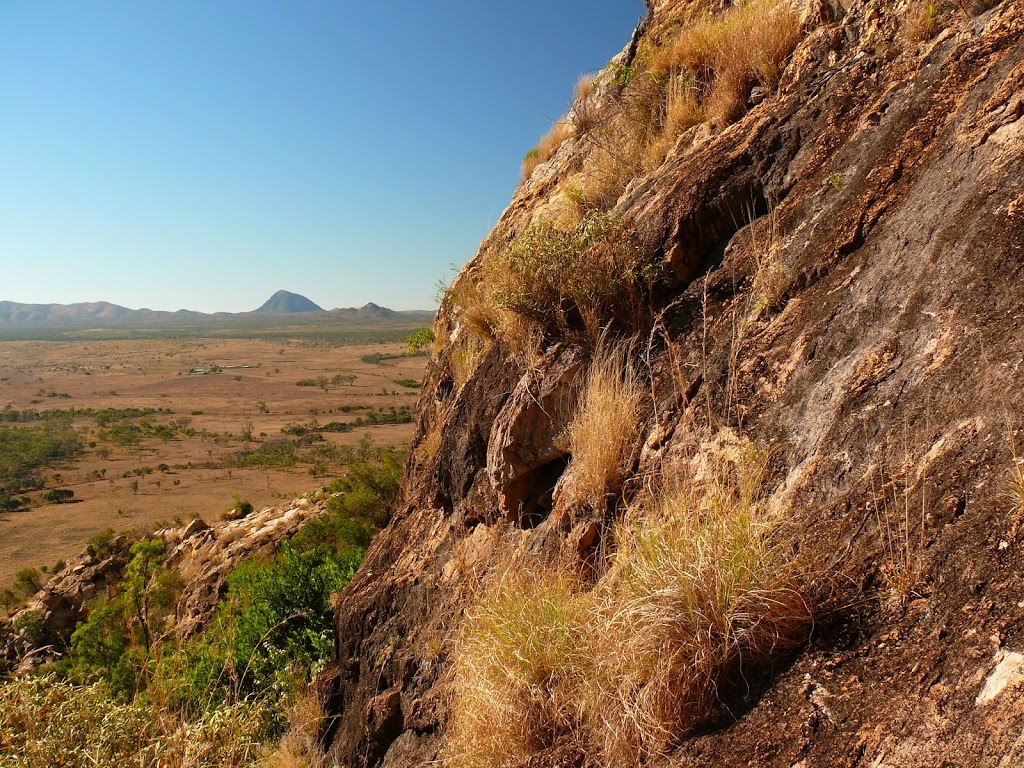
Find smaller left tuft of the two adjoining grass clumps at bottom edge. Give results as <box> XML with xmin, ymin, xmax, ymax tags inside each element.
<box><xmin>445</xmin><ymin>573</ymin><xmax>580</xmax><ymax>768</ymax></box>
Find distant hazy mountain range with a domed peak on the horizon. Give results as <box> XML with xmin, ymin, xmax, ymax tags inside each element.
<box><xmin>0</xmin><ymin>291</ymin><xmax>434</xmax><ymax>329</ymax></box>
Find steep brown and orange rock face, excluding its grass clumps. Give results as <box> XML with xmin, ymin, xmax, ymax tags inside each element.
<box><xmin>323</xmin><ymin>0</ymin><xmax>1024</xmax><ymax>768</ymax></box>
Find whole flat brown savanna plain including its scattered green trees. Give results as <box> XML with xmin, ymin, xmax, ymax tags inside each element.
<box><xmin>0</xmin><ymin>331</ymin><xmax>426</xmax><ymax>585</ymax></box>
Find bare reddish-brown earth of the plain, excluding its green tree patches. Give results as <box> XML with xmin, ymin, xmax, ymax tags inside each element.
<box><xmin>0</xmin><ymin>339</ymin><xmax>425</xmax><ymax>585</ymax></box>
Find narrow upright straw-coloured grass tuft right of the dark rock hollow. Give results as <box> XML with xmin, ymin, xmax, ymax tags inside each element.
<box><xmin>567</xmin><ymin>344</ymin><xmax>644</xmax><ymax>511</ymax></box>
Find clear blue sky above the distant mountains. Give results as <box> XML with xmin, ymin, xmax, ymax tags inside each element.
<box><xmin>0</xmin><ymin>0</ymin><xmax>644</xmax><ymax>311</ymax></box>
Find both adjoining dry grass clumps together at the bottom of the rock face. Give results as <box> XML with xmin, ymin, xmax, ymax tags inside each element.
<box><xmin>446</xmin><ymin>439</ymin><xmax>811</xmax><ymax>768</ymax></box>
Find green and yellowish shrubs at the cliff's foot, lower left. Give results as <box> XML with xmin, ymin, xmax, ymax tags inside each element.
<box><xmin>0</xmin><ymin>440</ymin><xmax>387</xmax><ymax>768</ymax></box>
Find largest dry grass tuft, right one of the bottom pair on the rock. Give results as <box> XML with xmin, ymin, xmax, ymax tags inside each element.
<box><xmin>585</xmin><ymin>443</ymin><xmax>811</xmax><ymax>765</ymax></box>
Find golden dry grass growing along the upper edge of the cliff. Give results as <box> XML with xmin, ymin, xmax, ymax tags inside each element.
<box><xmin>523</xmin><ymin>0</ymin><xmax>804</xmax><ymax>212</ymax></box>
